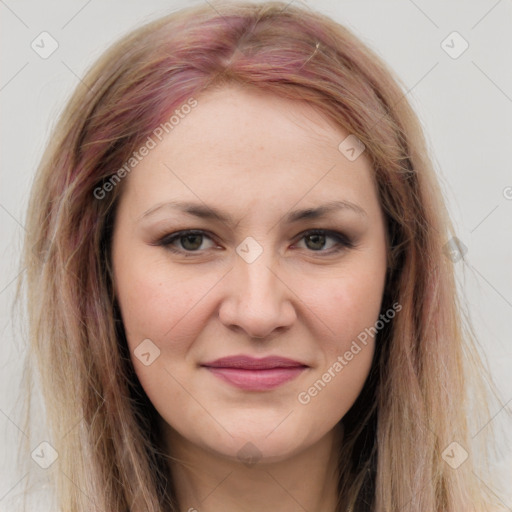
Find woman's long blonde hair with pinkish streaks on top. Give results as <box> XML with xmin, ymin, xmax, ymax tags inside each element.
<box><xmin>18</xmin><ymin>2</ymin><xmax>506</xmax><ymax>512</ymax></box>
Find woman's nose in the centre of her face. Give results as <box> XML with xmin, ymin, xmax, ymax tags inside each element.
<box><xmin>219</xmin><ymin>251</ymin><xmax>297</xmax><ymax>339</ymax></box>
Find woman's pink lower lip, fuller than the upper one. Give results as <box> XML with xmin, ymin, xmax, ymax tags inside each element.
<box><xmin>206</xmin><ymin>366</ymin><xmax>306</xmax><ymax>391</ymax></box>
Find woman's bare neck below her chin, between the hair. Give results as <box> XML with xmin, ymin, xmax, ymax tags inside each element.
<box><xmin>162</xmin><ymin>427</ymin><xmax>342</xmax><ymax>512</ymax></box>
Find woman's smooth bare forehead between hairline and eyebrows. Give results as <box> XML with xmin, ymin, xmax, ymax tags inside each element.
<box><xmin>118</xmin><ymin>85</ymin><xmax>375</xmax><ymax>216</ymax></box>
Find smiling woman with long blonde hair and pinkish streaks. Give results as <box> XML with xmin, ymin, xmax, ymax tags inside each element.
<box><xmin>19</xmin><ymin>2</ymin><xmax>504</xmax><ymax>512</ymax></box>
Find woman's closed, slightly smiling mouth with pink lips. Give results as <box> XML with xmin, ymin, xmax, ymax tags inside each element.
<box><xmin>201</xmin><ymin>355</ymin><xmax>309</xmax><ymax>391</ymax></box>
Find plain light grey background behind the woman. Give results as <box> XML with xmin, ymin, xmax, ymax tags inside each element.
<box><xmin>0</xmin><ymin>0</ymin><xmax>512</xmax><ymax>512</ymax></box>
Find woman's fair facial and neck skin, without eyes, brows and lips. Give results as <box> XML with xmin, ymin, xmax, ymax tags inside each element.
<box><xmin>112</xmin><ymin>86</ymin><xmax>386</xmax><ymax>512</ymax></box>
